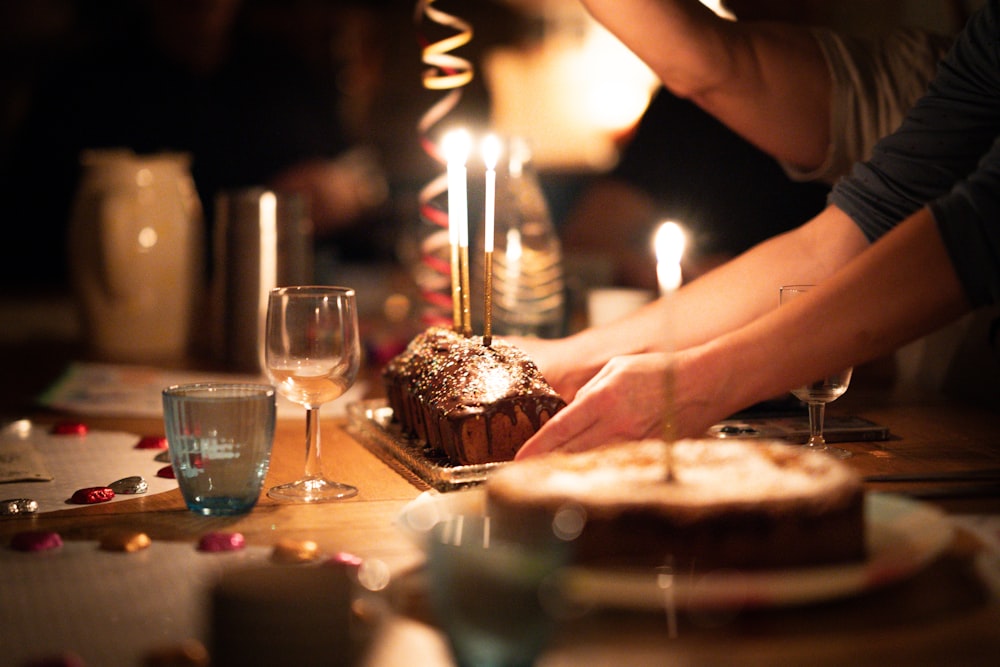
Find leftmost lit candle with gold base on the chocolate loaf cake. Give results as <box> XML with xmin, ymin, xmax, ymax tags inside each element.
<box><xmin>442</xmin><ymin>130</ymin><xmax>471</xmax><ymax>331</ymax></box>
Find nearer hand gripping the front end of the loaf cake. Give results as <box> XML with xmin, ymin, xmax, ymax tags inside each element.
<box><xmin>515</xmin><ymin>354</ymin><xmax>671</xmax><ymax>459</ymax></box>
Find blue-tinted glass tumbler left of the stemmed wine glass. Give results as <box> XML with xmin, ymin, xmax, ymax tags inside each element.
<box><xmin>163</xmin><ymin>382</ymin><xmax>276</xmax><ymax>516</ymax></box>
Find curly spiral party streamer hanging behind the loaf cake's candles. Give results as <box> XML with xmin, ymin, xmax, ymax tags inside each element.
<box><xmin>414</xmin><ymin>0</ymin><xmax>473</xmax><ymax>325</ymax></box>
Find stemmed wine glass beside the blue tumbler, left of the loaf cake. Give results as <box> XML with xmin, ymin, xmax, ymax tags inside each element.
<box><xmin>264</xmin><ymin>286</ymin><xmax>361</xmax><ymax>503</ymax></box>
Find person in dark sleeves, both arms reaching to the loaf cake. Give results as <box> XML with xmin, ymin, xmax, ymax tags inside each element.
<box><xmin>519</xmin><ymin>0</ymin><xmax>1000</xmax><ymax>456</ymax></box>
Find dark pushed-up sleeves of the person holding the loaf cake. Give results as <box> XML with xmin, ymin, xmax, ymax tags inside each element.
<box><xmin>831</xmin><ymin>0</ymin><xmax>1000</xmax><ymax>305</ymax></box>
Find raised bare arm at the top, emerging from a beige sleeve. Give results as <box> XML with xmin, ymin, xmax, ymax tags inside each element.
<box><xmin>581</xmin><ymin>0</ymin><xmax>830</xmax><ymax>169</ymax></box>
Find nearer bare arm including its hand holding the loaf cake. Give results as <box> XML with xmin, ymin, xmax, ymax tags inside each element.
<box><xmin>517</xmin><ymin>207</ymin><xmax>969</xmax><ymax>458</ymax></box>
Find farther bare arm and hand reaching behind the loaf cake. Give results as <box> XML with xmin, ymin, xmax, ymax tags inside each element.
<box><xmin>516</xmin><ymin>209</ymin><xmax>868</xmax><ymax>400</ymax></box>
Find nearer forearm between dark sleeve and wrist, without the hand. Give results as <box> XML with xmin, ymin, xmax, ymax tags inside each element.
<box><xmin>678</xmin><ymin>209</ymin><xmax>969</xmax><ymax>428</ymax></box>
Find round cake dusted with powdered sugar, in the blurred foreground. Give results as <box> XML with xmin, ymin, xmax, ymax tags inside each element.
<box><xmin>486</xmin><ymin>440</ymin><xmax>865</xmax><ymax>571</ymax></box>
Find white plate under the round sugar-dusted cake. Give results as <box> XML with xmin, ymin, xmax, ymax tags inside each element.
<box><xmin>399</xmin><ymin>488</ymin><xmax>954</xmax><ymax>610</ymax></box>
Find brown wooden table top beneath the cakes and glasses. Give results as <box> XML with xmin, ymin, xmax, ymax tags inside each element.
<box><xmin>0</xmin><ymin>392</ymin><xmax>1000</xmax><ymax>667</ymax></box>
